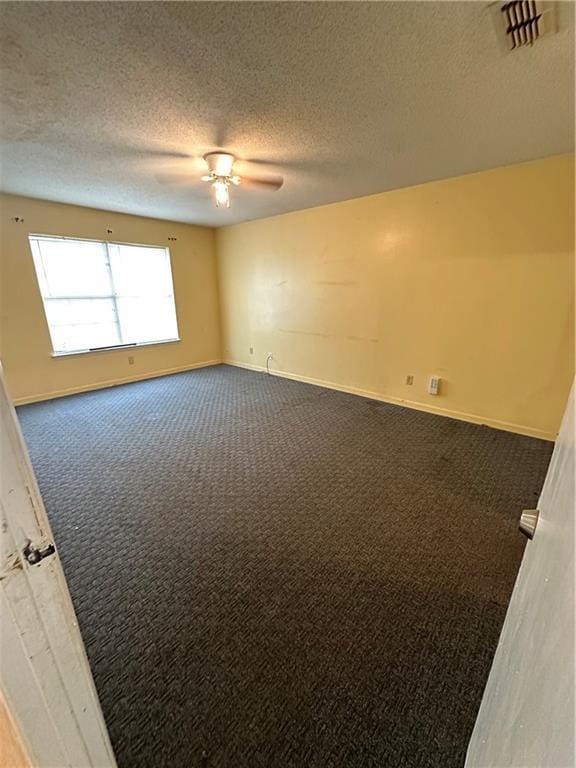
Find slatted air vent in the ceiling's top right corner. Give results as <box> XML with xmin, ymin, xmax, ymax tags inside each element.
<box><xmin>492</xmin><ymin>0</ymin><xmax>556</xmax><ymax>51</ymax></box>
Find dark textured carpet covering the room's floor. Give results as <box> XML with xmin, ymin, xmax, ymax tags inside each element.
<box><xmin>18</xmin><ymin>366</ymin><xmax>552</xmax><ymax>768</ymax></box>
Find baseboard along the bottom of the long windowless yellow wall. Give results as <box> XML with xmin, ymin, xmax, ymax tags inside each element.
<box><xmin>222</xmin><ymin>360</ymin><xmax>556</xmax><ymax>441</ymax></box>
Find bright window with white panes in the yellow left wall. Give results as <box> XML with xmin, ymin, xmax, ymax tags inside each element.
<box><xmin>30</xmin><ymin>235</ymin><xmax>178</xmax><ymax>354</ymax></box>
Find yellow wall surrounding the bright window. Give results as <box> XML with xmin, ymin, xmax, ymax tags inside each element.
<box><xmin>0</xmin><ymin>195</ymin><xmax>220</xmax><ymax>402</ymax></box>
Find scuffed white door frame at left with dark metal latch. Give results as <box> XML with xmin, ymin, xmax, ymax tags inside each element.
<box><xmin>0</xmin><ymin>369</ymin><xmax>116</xmax><ymax>768</ymax></box>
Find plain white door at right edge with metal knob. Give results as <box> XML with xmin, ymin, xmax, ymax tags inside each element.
<box><xmin>466</xmin><ymin>387</ymin><xmax>576</xmax><ymax>768</ymax></box>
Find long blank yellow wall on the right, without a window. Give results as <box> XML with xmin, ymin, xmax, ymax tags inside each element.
<box><xmin>217</xmin><ymin>155</ymin><xmax>574</xmax><ymax>438</ymax></box>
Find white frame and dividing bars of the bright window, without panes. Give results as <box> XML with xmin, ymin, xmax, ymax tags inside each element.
<box><xmin>28</xmin><ymin>232</ymin><xmax>182</xmax><ymax>358</ymax></box>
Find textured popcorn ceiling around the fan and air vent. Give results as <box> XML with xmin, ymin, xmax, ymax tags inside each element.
<box><xmin>0</xmin><ymin>2</ymin><xmax>574</xmax><ymax>226</ymax></box>
